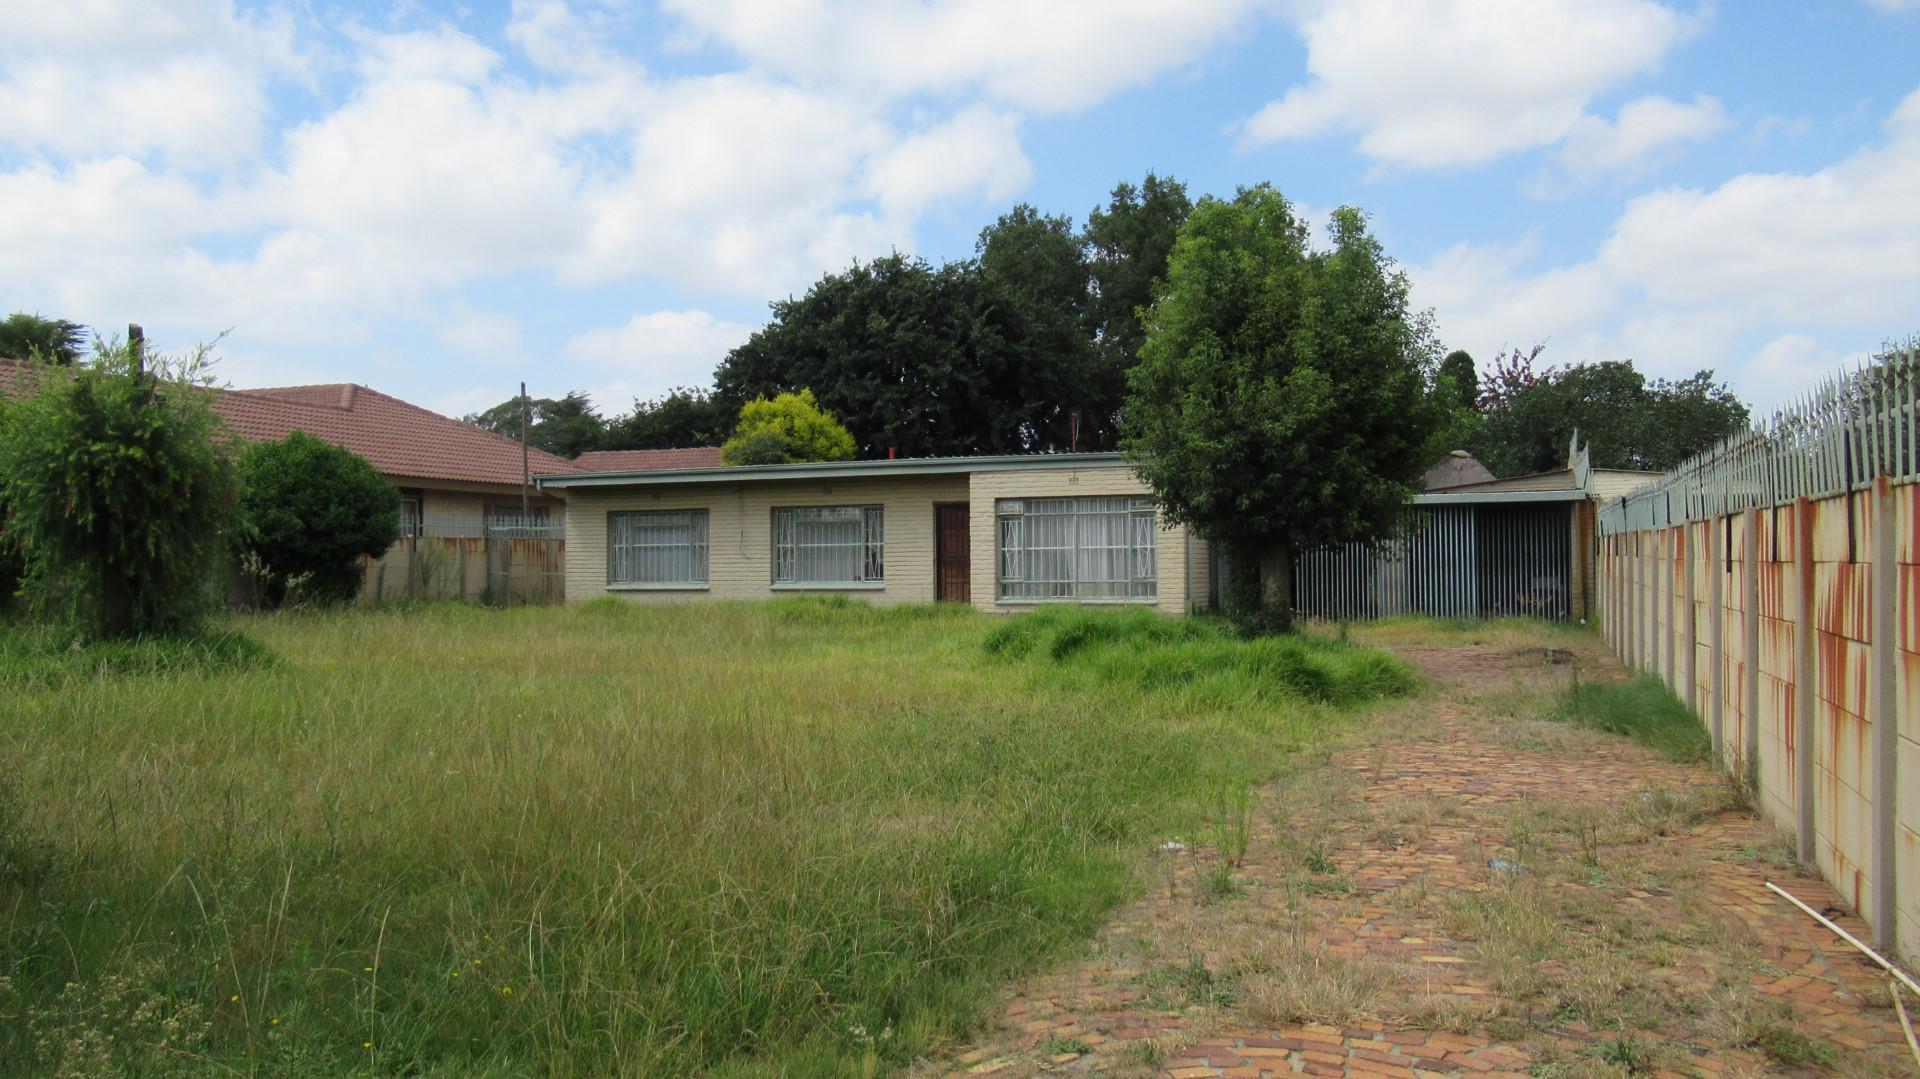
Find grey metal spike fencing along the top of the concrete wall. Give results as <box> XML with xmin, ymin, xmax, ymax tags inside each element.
<box><xmin>1599</xmin><ymin>346</ymin><xmax>1920</xmax><ymax>536</ymax></box>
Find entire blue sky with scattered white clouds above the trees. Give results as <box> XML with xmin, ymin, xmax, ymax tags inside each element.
<box><xmin>0</xmin><ymin>0</ymin><xmax>1920</xmax><ymax>415</ymax></box>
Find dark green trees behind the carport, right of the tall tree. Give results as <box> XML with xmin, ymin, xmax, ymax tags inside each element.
<box><xmin>1471</xmin><ymin>348</ymin><xmax>1747</xmax><ymax>476</ymax></box>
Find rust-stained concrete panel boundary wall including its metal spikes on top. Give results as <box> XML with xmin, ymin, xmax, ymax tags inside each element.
<box><xmin>1599</xmin><ymin>348</ymin><xmax>1920</xmax><ymax>960</ymax></box>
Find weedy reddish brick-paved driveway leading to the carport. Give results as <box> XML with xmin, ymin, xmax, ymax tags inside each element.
<box><xmin>918</xmin><ymin>637</ymin><xmax>1912</xmax><ymax>1079</ymax></box>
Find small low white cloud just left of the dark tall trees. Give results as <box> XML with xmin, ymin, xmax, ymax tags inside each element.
<box><xmin>566</xmin><ymin>309</ymin><xmax>753</xmax><ymax>397</ymax></box>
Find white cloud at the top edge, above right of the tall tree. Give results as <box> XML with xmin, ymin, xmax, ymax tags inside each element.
<box><xmin>1240</xmin><ymin>0</ymin><xmax>1692</xmax><ymax>167</ymax></box>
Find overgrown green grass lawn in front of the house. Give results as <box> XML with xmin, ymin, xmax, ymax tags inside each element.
<box><xmin>0</xmin><ymin>601</ymin><xmax>1413</xmax><ymax>1075</ymax></box>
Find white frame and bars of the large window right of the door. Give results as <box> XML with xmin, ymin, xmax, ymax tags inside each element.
<box><xmin>993</xmin><ymin>493</ymin><xmax>1160</xmax><ymax>607</ymax></box>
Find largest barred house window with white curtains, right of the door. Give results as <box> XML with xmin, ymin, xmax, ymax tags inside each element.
<box><xmin>995</xmin><ymin>495</ymin><xmax>1160</xmax><ymax>603</ymax></box>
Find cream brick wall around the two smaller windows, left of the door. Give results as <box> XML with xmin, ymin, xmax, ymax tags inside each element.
<box><xmin>566</xmin><ymin>474</ymin><xmax>968</xmax><ymax>603</ymax></box>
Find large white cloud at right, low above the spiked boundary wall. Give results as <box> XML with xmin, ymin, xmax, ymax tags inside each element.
<box><xmin>1411</xmin><ymin>90</ymin><xmax>1920</xmax><ymax>405</ymax></box>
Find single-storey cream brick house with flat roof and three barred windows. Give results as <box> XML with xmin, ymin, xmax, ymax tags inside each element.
<box><xmin>538</xmin><ymin>453</ymin><xmax>1212</xmax><ymax>614</ymax></box>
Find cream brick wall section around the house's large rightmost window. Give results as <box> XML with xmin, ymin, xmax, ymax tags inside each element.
<box><xmin>968</xmin><ymin>465</ymin><xmax>1208</xmax><ymax>614</ymax></box>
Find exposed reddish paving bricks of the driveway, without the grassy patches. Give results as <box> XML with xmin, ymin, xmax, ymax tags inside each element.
<box><xmin>925</xmin><ymin>641</ymin><xmax>1907</xmax><ymax>1079</ymax></box>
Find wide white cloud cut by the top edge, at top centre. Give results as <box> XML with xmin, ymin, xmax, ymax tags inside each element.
<box><xmin>664</xmin><ymin>0</ymin><xmax>1256</xmax><ymax>111</ymax></box>
